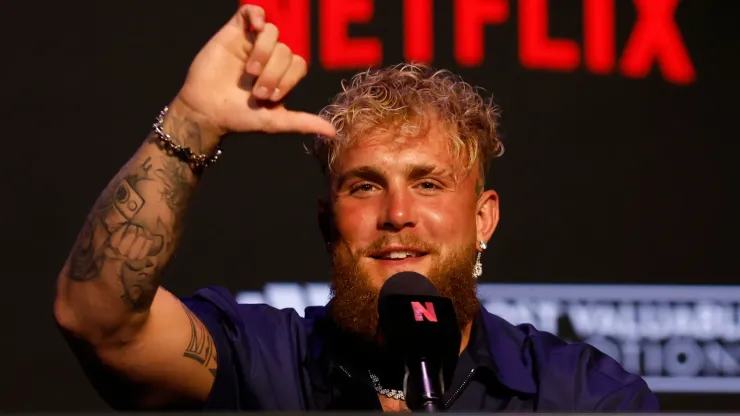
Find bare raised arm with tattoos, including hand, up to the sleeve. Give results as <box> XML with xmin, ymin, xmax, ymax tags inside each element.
<box><xmin>54</xmin><ymin>5</ymin><xmax>335</xmax><ymax>409</ymax></box>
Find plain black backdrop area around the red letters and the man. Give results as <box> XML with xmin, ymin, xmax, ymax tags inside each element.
<box><xmin>0</xmin><ymin>0</ymin><xmax>740</xmax><ymax>410</ymax></box>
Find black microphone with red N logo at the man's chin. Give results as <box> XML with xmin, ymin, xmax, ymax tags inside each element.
<box><xmin>378</xmin><ymin>272</ymin><xmax>461</xmax><ymax>412</ymax></box>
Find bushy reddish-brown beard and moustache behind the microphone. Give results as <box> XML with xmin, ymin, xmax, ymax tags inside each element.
<box><xmin>329</xmin><ymin>234</ymin><xmax>480</xmax><ymax>341</ymax></box>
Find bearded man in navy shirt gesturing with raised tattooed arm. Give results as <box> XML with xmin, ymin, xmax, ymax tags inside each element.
<box><xmin>55</xmin><ymin>6</ymin><xmax>657</xmax><ymax>412</ymax></box>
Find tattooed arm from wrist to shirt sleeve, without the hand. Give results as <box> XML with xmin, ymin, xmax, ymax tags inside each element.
<box><xmin>55</xmin><ymin>100</ymin><xmax>218</xmax><ymax>407</ymax></box>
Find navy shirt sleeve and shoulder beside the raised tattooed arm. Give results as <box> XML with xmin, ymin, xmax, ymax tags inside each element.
<box><xmin>182</xmin><ymin>287</ymin><xmax>306</xmax><ymax>411</ymax></box>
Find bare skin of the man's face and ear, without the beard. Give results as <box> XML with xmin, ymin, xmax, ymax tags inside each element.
<box><xmin>320</xmin><ymin>128</ymin><xmax>499</xmax><ymax>411</ymax></box>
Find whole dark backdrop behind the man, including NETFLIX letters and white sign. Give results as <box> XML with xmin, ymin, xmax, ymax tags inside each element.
<box><xmin>0</xmin><ymin>0</ymin><xmax>740</xmax><ymax>411</ymax></box>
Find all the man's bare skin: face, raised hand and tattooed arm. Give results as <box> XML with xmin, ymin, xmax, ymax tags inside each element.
<box><xmin>54</xmin><ymin>5</ymin><xmax>498</xmax><ymax>410</ymax></box>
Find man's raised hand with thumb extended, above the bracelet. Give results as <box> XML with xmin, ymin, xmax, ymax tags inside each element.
<box><xmin>176</xmin><ymin>5</ymin><xmax>335</xmax><ymax>147</ymax></box>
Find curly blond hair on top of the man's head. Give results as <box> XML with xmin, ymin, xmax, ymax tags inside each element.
<box><xmin>308</xmin><ymin>63</ymin><xmax>504</xmax><ymax>180</ymax></box>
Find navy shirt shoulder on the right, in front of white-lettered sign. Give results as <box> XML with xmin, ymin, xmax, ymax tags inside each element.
<box><xmin>484</xmin><ymin>312</ymin><xmax>657</xmax><ymax>410</ymax></box>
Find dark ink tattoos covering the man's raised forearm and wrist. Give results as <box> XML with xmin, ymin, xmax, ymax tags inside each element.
<box><xmin>69</xmin><ymin>113</ymin><xmax>201</xmax><ymax>311</ymax></box>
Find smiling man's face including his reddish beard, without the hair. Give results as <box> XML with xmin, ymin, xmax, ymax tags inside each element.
<box><xmin>322</xmin><ymin>122</ymin><xmax>498</xmax><ymax>336</ymax></box>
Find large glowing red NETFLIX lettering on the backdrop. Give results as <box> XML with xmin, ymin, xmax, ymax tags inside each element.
<box><xmin>240</xmin><ymin>0</ymin><xmax>696</xmax><ymax>84</ymax></box>
